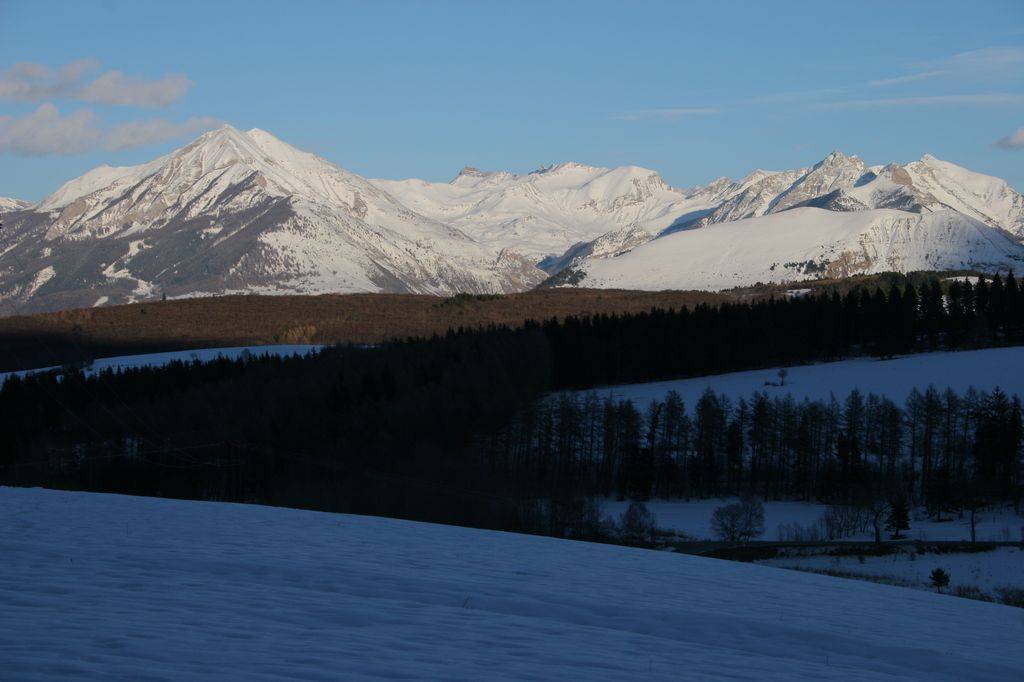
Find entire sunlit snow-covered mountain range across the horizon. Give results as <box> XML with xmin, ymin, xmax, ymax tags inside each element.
<box><xmin>0</xmin><ymin>126</ymin><xmax>1024</xmax><ymax>313</ymax></box>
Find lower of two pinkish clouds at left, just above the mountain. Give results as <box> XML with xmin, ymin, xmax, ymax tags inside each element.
<box><xmin>0</xmin><ymin>103</ymin><xmax>220</xmax><ymax>157</ymax></box>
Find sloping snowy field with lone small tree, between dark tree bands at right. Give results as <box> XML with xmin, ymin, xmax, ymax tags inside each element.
<box><xmin>584</xmin><ymin>346</ymin><xmax>1024</xmax><ymax>409</ymax></box>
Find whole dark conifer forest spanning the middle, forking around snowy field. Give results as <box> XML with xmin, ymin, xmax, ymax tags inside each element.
<box><xmin>0</xmin><ymin>274</ymin><xmax>1024</xmax><ymax>535</ymax></box>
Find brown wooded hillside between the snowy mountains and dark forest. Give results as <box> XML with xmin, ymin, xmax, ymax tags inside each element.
<box><xmin>0</xmin><ymin>289</ymin><xmax>736</xmax><ymax>371</ymax></box>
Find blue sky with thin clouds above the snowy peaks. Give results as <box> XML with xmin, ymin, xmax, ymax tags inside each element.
<box><xmin>0</xmin><ymin>0</ymin><xmax>1024</xmax><ymax>200</ymax></box>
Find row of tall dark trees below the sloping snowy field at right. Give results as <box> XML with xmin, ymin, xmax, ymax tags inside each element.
<box><xmin>481</xmin><ymin>387</ymin><xmax>1024</xmax><ymax>518</ymax></box>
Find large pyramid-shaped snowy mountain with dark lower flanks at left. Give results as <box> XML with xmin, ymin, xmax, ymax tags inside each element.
<box><xmin>0</xmin><ymin>126</ymin><xmax>545</xmax><ymax>309</ymax></box>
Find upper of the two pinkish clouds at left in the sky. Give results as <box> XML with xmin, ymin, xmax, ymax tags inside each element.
<box><xmin>0</xmin><ymin>57</ymin><xmax>193</xmax><ymax>108</ymax></box>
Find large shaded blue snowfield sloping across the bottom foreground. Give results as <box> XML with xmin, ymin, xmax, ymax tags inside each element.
<box><xmin>6</xmin><ymin>488</ymin><xmax>1024</xmax><ymax>680</ymax></box>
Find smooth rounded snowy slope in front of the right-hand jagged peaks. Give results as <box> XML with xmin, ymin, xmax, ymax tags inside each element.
<box><xmin>572</xmin><ymin>207</ymin><xmax>1024</xmax><ymax>291</ymax></box>
